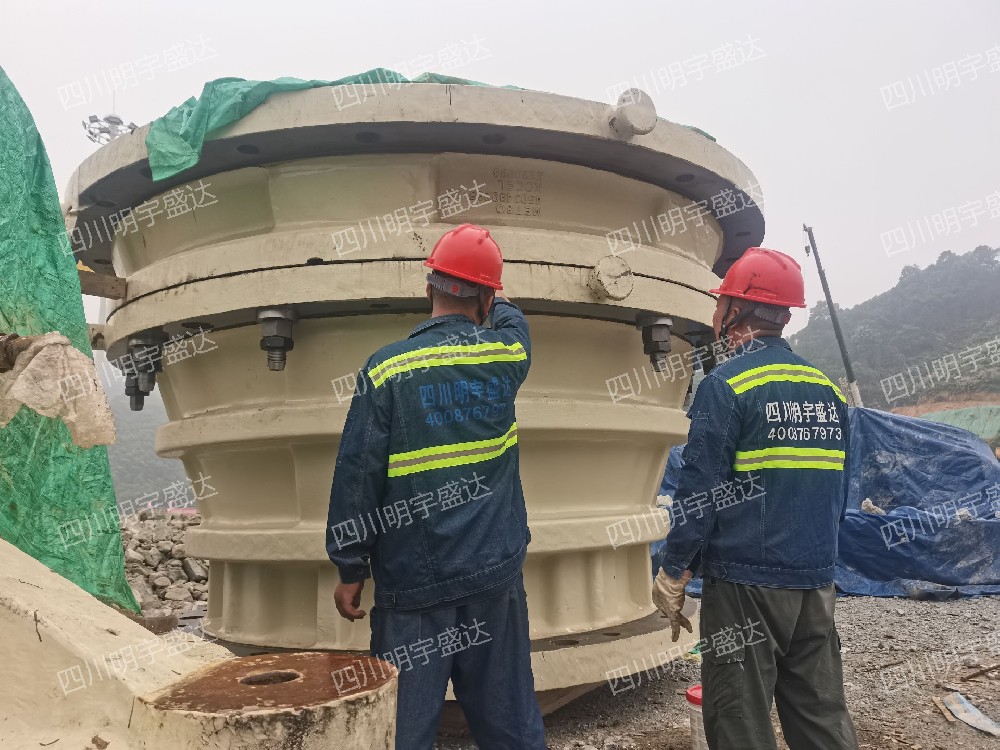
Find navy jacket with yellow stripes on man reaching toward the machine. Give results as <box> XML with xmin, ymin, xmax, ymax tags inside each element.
<box><xmin>326</xmin><ymin>299</ymin><xmax>531</xmax><ymax>609</ymax></box>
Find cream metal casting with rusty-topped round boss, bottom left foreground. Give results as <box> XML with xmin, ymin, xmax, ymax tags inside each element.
<box><xmin>0</xmin><ymin>540</ymin><xmax>396</xmax><ymax>750</ymax></box>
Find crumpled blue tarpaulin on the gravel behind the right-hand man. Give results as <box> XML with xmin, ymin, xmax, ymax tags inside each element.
<box><xmin>651</xmin><ymin>408</ymin><xmax>1000</xmax><ymax>599</ymax></box>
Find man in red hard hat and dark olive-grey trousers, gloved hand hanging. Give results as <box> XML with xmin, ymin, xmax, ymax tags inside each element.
<box><xmin>653</xmin><ymin>248</ymin><xmax>857</xmax><ymax>750</ymax></box>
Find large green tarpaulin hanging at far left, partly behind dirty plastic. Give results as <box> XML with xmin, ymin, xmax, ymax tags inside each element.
<box><xmin>0</xmin><ymin>69</ymin><xmax>139</xmax><ymax>611</ymax></box>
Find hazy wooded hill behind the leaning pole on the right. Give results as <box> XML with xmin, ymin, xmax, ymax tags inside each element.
<box><xmin>789</xmin><ymin>245</ymin><xmax>1000</xmax><ymax>424</ymax></box>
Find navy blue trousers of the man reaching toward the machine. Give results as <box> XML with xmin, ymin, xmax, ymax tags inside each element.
<box><xmin>371</xmin><ymin>576</ymin><xmax>545</xmax><ymax>750</ymax></box>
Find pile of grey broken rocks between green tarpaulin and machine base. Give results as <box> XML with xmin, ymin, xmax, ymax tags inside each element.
<box><xmin>122</xmin><ymin>510</ymin><xmax>208</xmax><ymax>617</ymax></box>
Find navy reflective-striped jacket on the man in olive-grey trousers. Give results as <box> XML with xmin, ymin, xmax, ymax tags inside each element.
<box><xmin>663</xmin><ymin>337</ymin><xmax>848</xmax><ymax>589</ymax></box>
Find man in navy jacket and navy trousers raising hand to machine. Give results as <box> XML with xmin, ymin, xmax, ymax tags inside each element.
<box><xmin>326</xmin><ymin>224</ymin><xmax>545</xmax><ymax>750</ymax></box>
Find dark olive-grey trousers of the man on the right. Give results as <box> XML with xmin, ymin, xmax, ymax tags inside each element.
<box><xmin>701</xmin><ymin>578</ymin><xmax>858</xmax><ymax>750</ymax></box>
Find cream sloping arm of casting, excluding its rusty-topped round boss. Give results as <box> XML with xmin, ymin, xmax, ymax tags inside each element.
<box><xmin>0</xmin><ymin>540</ymin><xmax>232</xmax><ymax>748</ymax></box>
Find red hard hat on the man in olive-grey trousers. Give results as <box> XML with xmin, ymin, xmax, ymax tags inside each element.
<box><xmin>709</xmin><ymin>247</ymin><xmax>806</xmax><ymax>307</ymax></box>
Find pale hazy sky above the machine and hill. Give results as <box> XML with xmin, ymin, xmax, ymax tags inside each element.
<box><xmin>0</xmin><ymin>0</ymin><xmax>1000</xmax><ymax>330</ymax></box>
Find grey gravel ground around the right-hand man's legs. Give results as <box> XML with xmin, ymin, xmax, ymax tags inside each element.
<box><xmin>438</xmin><ymin>597</ymin><xmax>1000</xmax><ymax>750</ymax></box>
